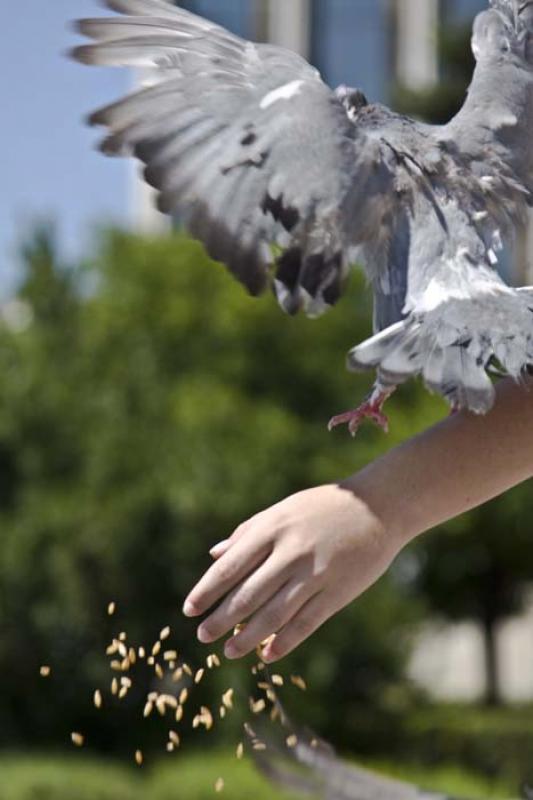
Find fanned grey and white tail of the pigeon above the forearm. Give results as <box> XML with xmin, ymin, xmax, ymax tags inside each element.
<box><xmin>348</xmin><ymin>287</ymin><xmax>533</xmax><ymax>414</ymax></box>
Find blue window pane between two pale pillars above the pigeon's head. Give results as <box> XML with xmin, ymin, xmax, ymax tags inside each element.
<box><xmin>312</xmin><ymin>0</ymin><xmax>391</xmax><ymax>101</ymax></box>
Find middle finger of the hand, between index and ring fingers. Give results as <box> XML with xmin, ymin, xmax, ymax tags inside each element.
<box><xmin>198</xmin><ymin>554</ymin><xmax>291</xmax><ymax>643</ymax></box>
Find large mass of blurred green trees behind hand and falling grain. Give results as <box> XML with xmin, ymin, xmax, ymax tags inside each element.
<box><xmin>0</xmin><ymin>227</ymin><xmax>436</xmax><ymax>754</ymax></box>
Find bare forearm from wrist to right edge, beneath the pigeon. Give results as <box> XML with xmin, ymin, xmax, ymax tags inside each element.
<box><xmin>342</xmin><ymin>380</ymin><xmax>533</xmax><ymax>542</ymax></box>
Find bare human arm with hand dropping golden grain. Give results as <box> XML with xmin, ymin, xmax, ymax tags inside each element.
<box><xmin>184</xmin><ymin>381</ymin><xmax>533</xmax><ymax>661</ymax></box>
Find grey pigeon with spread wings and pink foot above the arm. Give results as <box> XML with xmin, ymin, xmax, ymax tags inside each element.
<box><xmin>72</xmin><ymin>0</ymin><xmax>533</xmax><ymax>435</ymax></box>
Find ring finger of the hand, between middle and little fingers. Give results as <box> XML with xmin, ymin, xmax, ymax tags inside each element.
<box><xmin>224</xmin><ymin>579</ymin><xmax>317</xmax><ymax>658</ymax></box>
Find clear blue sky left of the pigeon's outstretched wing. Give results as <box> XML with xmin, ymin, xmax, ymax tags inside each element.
<box><xmin>0</xmin><ymin>0</ymin><xmax>132</xmax><ymax>293</ymax></box>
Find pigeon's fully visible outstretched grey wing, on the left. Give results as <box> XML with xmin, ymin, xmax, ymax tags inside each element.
<box><xmin>73</xmin><ymin>0</ymin><xmax>393</xmax><ymax>315</ymax></box>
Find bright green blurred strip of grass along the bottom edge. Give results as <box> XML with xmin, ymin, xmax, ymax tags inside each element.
<box><xmin>0</xmin><ymin>752</ymin><xmax>518</xmax><ymax>800</ymax></box>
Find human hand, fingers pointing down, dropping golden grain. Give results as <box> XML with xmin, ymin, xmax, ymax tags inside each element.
<box><xmin>183</xmin><ymin>485</ymin><xmax>401</xmax><ymax>663</ymax></box>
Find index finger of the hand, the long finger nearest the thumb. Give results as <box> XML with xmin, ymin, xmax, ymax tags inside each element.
<box><xmin>183</xmin><ymin>536</ymin><xmax>271</xmax><ymax>617</ymax></box>
